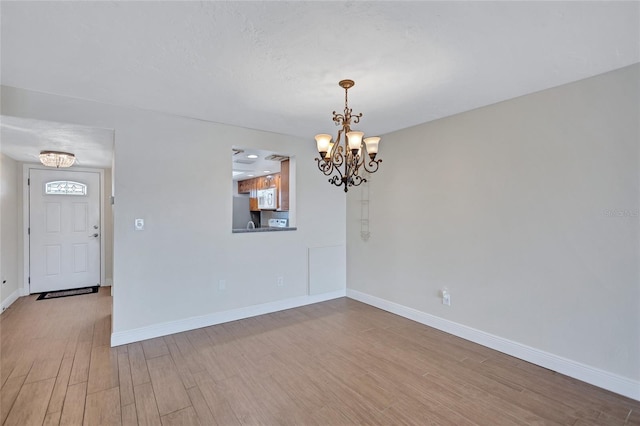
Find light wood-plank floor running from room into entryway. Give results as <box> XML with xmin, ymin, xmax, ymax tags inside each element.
<box><xmin>0</xmin><ymin>289</ymin><xmax>640</xmax><ymax>426</ymax></box>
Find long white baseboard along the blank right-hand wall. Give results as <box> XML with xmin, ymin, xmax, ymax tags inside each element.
<box><xmin>347</xmin><ymin>289</ymin><xmax>640</xmax><ymax>401</ymax></box>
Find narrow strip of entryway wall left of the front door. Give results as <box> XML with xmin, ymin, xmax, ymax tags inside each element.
<box><xmin>0</xmin><ymin>154</ymin><xmax>20</xmax><ymax>312</ymax></box>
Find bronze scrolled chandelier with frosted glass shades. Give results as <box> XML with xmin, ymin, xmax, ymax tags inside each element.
<box><xmin>316</xmin><ymin>80</ymin><xmax>382</xmax><ymax>192</ymax></box>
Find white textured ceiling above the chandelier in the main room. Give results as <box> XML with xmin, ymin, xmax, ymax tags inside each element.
<box><xmin>0</xmin><ymin>1</ymin><xmax>640</xmax><ymax>165</ymax></box>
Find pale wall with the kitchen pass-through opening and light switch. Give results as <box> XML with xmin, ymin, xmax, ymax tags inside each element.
<box><xmin>2</xmin><ymin>87</ymin><xmax>346</xmax><ymax>342</ymax></box>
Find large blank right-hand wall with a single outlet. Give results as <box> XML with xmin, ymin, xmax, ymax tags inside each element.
<box><xmin>347</xmin><ymin>65</ymin><xmax>640</xmax><ymax>388</ymax></box>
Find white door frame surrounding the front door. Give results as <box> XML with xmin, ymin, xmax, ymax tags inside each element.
<box><xmin>19</xmin><ymin>163</ymin><xmax>106</xmax><ymax>296</ymax></box>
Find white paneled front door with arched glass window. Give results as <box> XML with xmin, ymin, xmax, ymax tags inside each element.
<box><xmin>29</xmin><ymin>169</ymin><xmax>101</xmax><ymax>293</ymax></box>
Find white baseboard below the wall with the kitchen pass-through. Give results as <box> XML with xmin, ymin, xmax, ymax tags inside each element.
<box><xmin>111</xmin><ymin>290</ymin><xmax>346</xmax><ymax>347</ymax></box>
